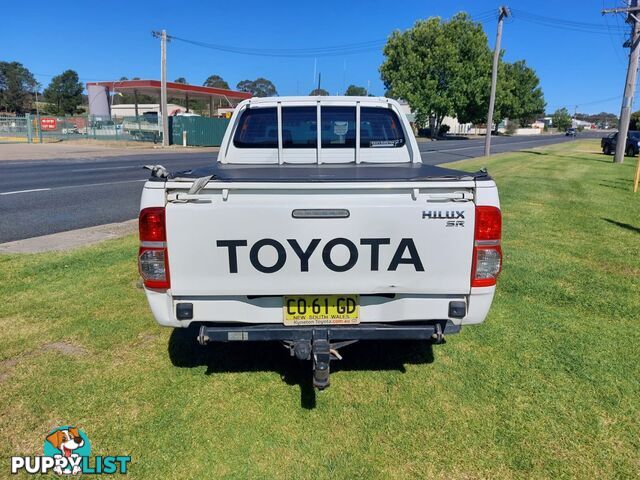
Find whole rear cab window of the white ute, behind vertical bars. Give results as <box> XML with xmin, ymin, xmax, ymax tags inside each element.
<box><xmin>233</xmin><ymin>106</ymin><xmax>406</xmax><ymax>148</ymax></box>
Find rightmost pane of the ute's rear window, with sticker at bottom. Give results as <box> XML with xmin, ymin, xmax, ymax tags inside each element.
<box><xmin>360</xmin><ymin>107</ymin><xmax>406</xmax><ymax>148</ymax></box>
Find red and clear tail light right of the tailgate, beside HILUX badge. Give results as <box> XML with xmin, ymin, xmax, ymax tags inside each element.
<box><xmin>471</xmin><ymin>206</ymin><xmax>502</xmax><ymax>287</ymax></box>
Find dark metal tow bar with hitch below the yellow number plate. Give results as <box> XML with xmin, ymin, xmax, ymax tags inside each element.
<box><xmin>197</xmin><ymin>320</ymin><xmax>460</xmax><ymax>390</ymax></box>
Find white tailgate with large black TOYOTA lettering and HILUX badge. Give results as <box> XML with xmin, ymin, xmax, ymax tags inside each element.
<box><xmin>166</xmin><ymin>184</ymin><xmax>475</xmax><ymax>296</ymax></box>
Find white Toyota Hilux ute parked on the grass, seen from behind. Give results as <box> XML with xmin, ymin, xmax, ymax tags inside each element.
<box><xmin>138</xmin><ymin>97</ymin><xmax>502</xmax><ymax>388</ymax></box>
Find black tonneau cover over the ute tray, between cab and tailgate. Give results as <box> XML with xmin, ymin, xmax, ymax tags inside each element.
<box><xmin>161</xmin><ymin>163</ymin><xmax>490</xmax><ymax>183</ymax></box>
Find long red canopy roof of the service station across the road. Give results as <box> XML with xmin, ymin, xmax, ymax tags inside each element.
<box><xmin>87</xmin><ymin>80</ymin><xmax>252</xmax><ymax>100</ymax></box>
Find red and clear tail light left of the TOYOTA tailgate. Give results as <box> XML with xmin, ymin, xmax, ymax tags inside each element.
<box><xmin>138</xmin><ymin>207</ymin><xmax>171</xmax><ymax>289</ymax></box>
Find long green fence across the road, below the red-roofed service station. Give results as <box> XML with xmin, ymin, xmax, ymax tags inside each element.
<box><xmin>0</xmin><ymin>114</ymin><xmax>229</xmax><ymax>146</ymax></box>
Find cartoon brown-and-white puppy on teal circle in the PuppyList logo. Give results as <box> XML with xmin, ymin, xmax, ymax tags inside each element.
<box><xmin>44</xmin><ymin>427</ymin><xmax>91</xmax><ymax>475</ymax></box>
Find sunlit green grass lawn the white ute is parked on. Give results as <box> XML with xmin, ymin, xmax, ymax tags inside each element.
<box><xmin>0</xmin><ymin>141</ymin><xmax>640</xmax><ymax>479</ymax></box>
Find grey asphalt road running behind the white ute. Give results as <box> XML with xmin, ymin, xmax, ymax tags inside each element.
<box><xmin>0</xmin><ymin>135</ymin><xmax>600</xmax><ymax>243</ymax></box>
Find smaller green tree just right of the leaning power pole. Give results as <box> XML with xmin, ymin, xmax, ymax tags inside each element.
<box><xmin>494</xmin><ymin>60</ymin><xmax>546</xmax><ymax>127</ymax></box>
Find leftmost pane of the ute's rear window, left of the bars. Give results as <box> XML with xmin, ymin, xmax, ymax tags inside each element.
<box><xmin>233</xmin><ymin>108</ymin><xmax>278</xmax><ymax>148</ymax></box>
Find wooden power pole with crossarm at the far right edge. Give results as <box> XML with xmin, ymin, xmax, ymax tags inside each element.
<box><xmin>602</xmin><ymin>0</ymin><xmax>640</xmax><ymax>163</ymax></box>
